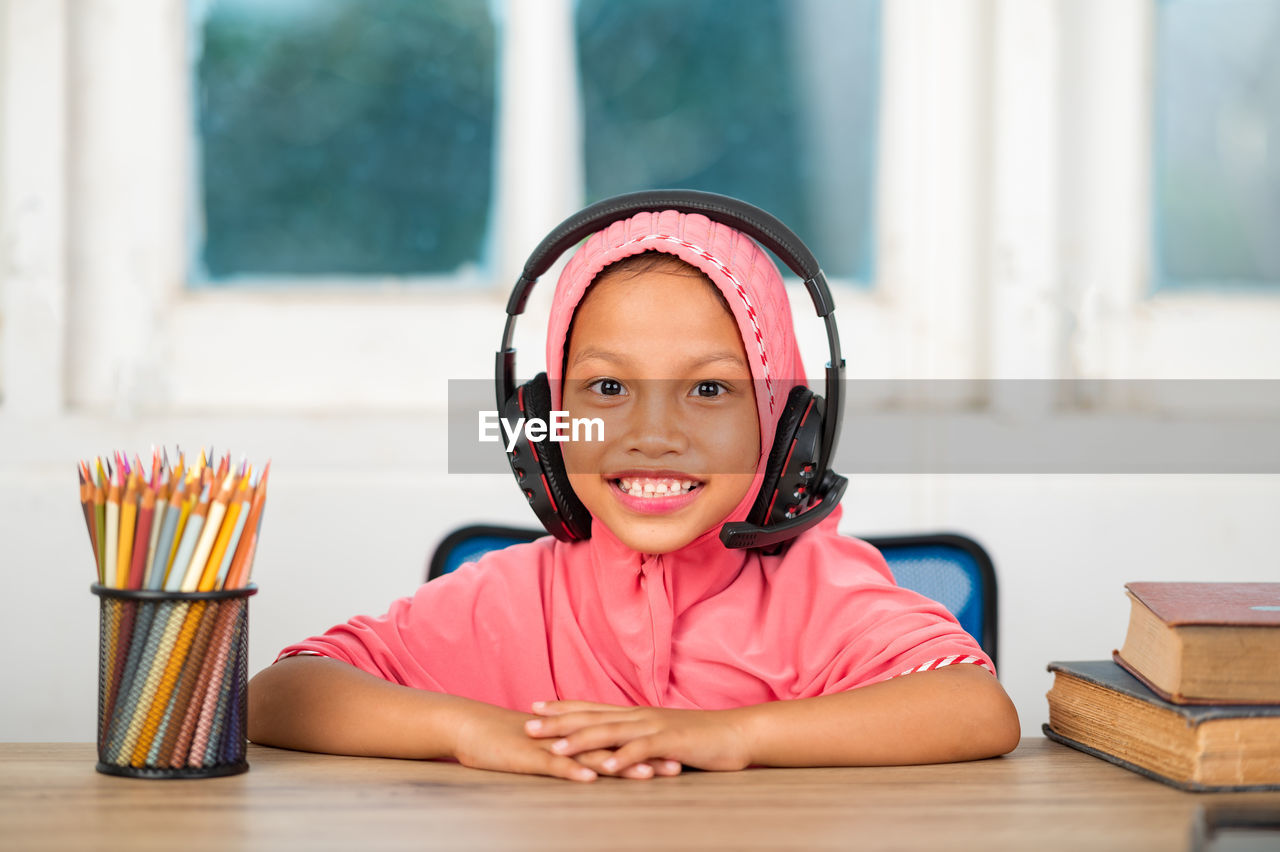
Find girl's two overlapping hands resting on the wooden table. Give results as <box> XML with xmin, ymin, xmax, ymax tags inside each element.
<box><xmin>454</xmin><ymin>701</ymin><xmax>750</xmax><ymax>782</ymax></box>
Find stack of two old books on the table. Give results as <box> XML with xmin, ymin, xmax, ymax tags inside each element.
<box><xmin>1044</xmin><ymin>582</ymin><xmax>1280</xmax><ymax>791</ymax></box>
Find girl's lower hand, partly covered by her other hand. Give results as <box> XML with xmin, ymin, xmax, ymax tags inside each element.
<box><xmin>453</xmin><ymin>705</ymin><xmax>680</xmax><ymax>782</ymax></box>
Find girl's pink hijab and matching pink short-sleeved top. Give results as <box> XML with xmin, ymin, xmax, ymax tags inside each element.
<box><xmin>280</xmin><ymin>210</ymin><xmax>995</xmax><ymax>711</ymax></box>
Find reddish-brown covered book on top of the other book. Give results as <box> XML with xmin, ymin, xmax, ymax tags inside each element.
<box><xmin>1112</xmin><ymin>583</ymin><xmax>1280</xmax><ymax>704</ymax></box>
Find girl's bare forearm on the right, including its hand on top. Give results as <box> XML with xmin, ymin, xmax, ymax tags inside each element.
<box><xmin>526</xmin><ymin>665</ymin><xmax>1020</xmax><ymax>769</ymax></box>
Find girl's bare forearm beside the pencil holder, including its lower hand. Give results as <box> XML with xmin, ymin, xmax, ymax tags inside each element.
<box><xmin>248</xmin><ymin>656</ymin><xmax>678</xmax><ymax>780</ymax></box>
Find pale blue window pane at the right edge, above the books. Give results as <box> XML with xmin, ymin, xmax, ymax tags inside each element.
<box><xmin>1153</xmin><ymin>0</ymin><xmax>1280</xmax><ymax>288</ymax></box>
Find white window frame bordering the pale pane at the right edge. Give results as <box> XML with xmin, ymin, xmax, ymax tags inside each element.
<box><xmin>1060</xmin><ymin>0</ymin><xmax>1280</xmax><ymax>391</ymax></box>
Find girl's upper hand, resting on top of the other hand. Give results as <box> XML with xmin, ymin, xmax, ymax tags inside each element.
<box><xmin>525</xmin><ymin>701</ymin><xmax>751</xmax><ymax>774</ymax></box>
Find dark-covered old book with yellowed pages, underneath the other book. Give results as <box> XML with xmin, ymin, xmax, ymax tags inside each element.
<box><xmin>1044</xmin><ymin>660</ymin><xmax>1280</xmax><ymax>792</ymax></box>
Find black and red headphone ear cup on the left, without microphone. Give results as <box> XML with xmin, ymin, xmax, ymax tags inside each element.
<box><xmin>503</xmin><ymin>372</ymin><xmax>591</xmax><ymax>541</ymax></box>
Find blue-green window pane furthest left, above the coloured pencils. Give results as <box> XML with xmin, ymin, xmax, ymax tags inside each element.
<box><xmin>189</xmin><ymin>0</ymin><xmax>495</xmax><ymax>285</ymax></box>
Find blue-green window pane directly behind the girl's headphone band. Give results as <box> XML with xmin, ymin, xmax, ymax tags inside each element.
<box><xmin>576</xmin><ymin>0</ymin><xmax>879</xmax><ymax>281</ymax></box>
